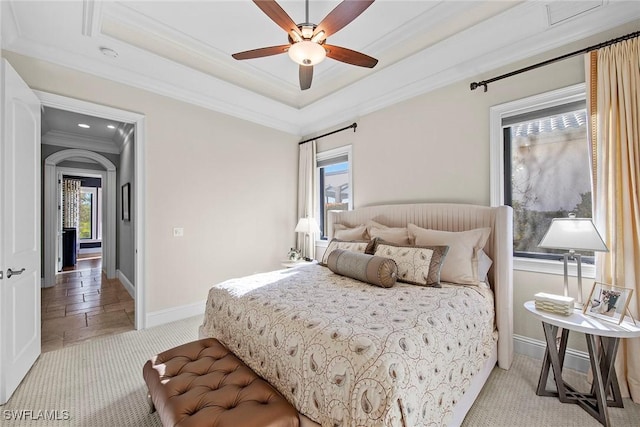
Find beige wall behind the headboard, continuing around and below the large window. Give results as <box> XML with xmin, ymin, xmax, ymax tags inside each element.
<box><xmin>314</xmin><ymin>22</ymin><xmax>639</xmax><ymax>349</ymax></box>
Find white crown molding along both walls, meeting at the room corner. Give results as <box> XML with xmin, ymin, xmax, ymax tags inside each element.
<box><xmin>2</xmin><ymin>0</ymin><xmax>640</xmax><ymax>136</ymax></box>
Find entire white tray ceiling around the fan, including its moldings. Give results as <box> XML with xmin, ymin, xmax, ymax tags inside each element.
<box><xmin>1</xmin><ymin>0</ymin><xmax>640</xmax><ymax>135</ymax></box>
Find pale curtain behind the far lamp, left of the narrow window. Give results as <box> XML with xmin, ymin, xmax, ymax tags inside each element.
<box><xmin>296</xmin><ymin>140</ymin><xmax>317</xmax><ymax>258</ymax></box>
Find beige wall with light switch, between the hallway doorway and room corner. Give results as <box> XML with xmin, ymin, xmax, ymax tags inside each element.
<box><xmin>3</xmin><ymin>52</ymin><xmax>298</xmax><ymax>313</ymax></box>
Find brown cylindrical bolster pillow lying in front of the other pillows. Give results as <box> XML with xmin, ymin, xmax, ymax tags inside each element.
<box><xmin>327</xmin><ymin>249</ymin><xmax>398</xmax><ymax>288</ymax></box>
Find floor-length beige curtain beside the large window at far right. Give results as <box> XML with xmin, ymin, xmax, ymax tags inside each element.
<box><xmin>586</xmin><ymin>38</ymin><xmax>640</xmax><ymax>403</ymax></box>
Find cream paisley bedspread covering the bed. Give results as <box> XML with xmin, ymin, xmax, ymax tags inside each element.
<box><xmin>200</xmin><ymin>265</ymin><xmax>497</xmax><ymax>427</ymax></box>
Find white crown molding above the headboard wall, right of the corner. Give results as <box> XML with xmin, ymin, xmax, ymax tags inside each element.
<box><xmin>302</xmin><ymin>2</ymin><xmax>640</xmax><ymax>135</ymax></box>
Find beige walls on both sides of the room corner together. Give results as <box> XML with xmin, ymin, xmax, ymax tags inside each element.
<box><xmin>6</xmin><ymin>21</ymin><xmax>640</xmax><ymax>347</ymax></box>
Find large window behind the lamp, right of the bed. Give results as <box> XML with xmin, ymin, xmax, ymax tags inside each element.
<box><xmin>491</xmin><ymin>85</ymin><xmax>593</xmax><ymax>271</ymax></box>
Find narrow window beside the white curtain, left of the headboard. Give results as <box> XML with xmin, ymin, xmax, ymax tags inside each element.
<box><xmin>316</xmin><ymin>146</ymin><xmax>353</xmax><ymax>240</ymax></box>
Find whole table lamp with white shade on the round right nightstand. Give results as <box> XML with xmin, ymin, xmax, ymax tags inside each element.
<box><xmin>538</xmin><ymin>214</ymin><xmax>609</xmax><ymax>308</ymax></box>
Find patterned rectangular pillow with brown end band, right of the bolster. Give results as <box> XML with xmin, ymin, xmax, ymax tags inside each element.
<box><xmin>374</xmin><ymin>240</ymin><xmax>449</xmax><ymax>288</ymax></box>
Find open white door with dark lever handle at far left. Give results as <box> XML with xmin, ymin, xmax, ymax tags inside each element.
<box><xmin>0</xmin><ymin>59</ymin><xmax>41</xmax><ymax>404</ymax></box>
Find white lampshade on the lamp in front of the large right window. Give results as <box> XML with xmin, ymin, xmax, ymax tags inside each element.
<box><xmin>538</xmin><ymin>216</ymin><xmax>609</xmax><ymax>252</ymax></box>
